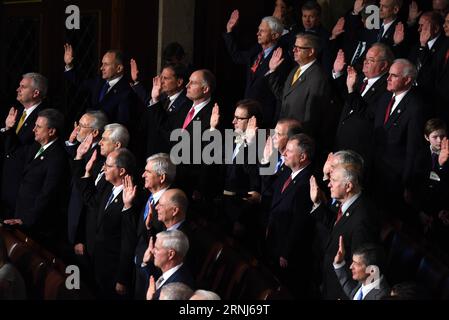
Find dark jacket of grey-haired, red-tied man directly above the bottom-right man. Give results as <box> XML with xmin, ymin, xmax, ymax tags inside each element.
<box><xmin>312</xmin><ymin>195</ymin><xmax>379</xmax><ymax>300</ymax></box>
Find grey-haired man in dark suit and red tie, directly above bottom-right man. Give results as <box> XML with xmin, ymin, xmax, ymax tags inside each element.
<box><xmin>310</xmin><ymin>164</ymin><xmax>379</xmax><ymax>300</ymax></box>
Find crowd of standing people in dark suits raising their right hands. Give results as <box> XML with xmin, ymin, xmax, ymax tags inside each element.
<box><xmin>0</xmin><ymin>0</ymin><xmax>449</xmax><ymax>300</ymax></box>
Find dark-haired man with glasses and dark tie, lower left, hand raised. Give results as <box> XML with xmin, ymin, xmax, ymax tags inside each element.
<box><xmin>77</xmin><ymin>148</ymin><xmax>136</xmax><ymax>299</ymax></box>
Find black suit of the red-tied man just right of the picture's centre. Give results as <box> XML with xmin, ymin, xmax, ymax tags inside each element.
<box><xmin>266</xmin><ymin>165</ymin><xmax>313</xmax><ymax>297</ymax></box>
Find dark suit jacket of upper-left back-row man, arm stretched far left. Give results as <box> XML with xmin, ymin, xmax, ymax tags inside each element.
<box><xmin>64</xmin><ymin>69</ymin><xmax>141</xmax><ymax>125</ymax></box>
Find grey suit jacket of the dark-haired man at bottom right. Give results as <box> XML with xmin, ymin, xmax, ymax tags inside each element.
<box><xmin>335</xmin><ymin>266</ymin><xmax>390</xmax><ymax>300</ymax></box>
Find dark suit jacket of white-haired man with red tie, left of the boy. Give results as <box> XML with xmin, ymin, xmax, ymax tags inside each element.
<box><xmin>374</xmin><ymin>88</ymin><xmax>424</xmax><ymax>191</ymax></box>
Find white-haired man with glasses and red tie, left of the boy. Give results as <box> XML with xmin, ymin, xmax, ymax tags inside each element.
<box><xmin>373</xmin><ymin>59</ymin><xmax>424</xmax><ymax>220</ymax></box>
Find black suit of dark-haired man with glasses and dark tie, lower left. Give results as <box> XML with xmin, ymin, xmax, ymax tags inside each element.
<box><xmin>77</xmin><ymin>178</ymin><xmax>135</xmax><ymax>298</ymax></box>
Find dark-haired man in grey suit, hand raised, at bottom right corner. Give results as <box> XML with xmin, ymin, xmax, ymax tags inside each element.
<box><xmin>334</xmin><ymin>240</ymin><xmax>390</xmax><ymax>300</ymax></box>
